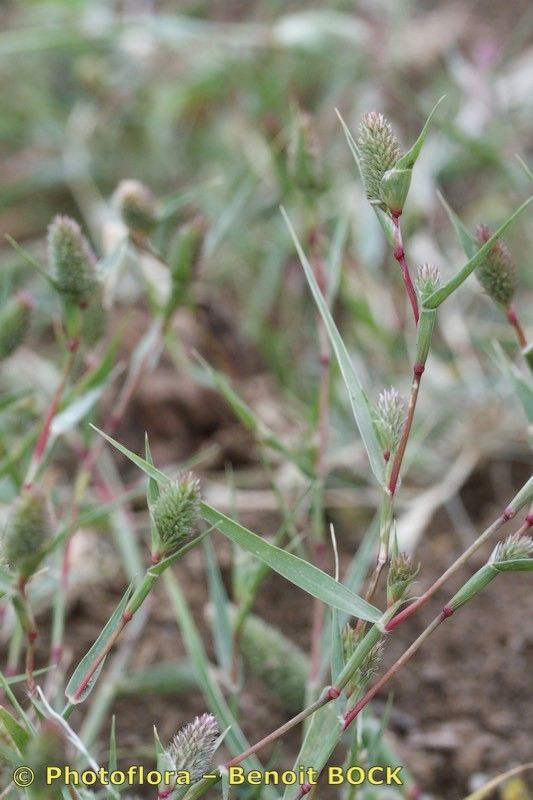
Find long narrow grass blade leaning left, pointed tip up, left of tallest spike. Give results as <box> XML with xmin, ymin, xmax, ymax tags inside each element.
<box><xmin>281</xmin><ymin>208</ymin><xmax>385</xmax><ymax>486</ymax></box>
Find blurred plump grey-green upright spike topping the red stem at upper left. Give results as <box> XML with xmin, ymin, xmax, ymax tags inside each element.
<box><xmin>48</xmin><ymin>216</ymin><xmax>96</xmax><ymax>305</ymax></box>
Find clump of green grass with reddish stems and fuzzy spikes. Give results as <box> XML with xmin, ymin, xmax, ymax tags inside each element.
<box><xmin>0</xmin><ymin>89</ymin><xmax>533</xmax><ymax>800</ymax></box>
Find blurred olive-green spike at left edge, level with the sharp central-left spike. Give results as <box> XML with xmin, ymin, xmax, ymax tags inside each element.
<box><xmin>2</xmin><ymin>489</ymin><xmax>52</xmax><ymax>578</ymax></box>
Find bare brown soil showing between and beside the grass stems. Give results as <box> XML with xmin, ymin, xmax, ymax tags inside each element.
<box><xmin>17</xmin><ymin>312</ymin><xmax>533</xmax><ymax>800</ymax></box>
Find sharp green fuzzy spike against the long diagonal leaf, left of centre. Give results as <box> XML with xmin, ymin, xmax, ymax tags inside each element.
<box><xmin>151</xmin><ymin>472</ymin><xmax>200</xmax><ymax>556</ymax></box>
